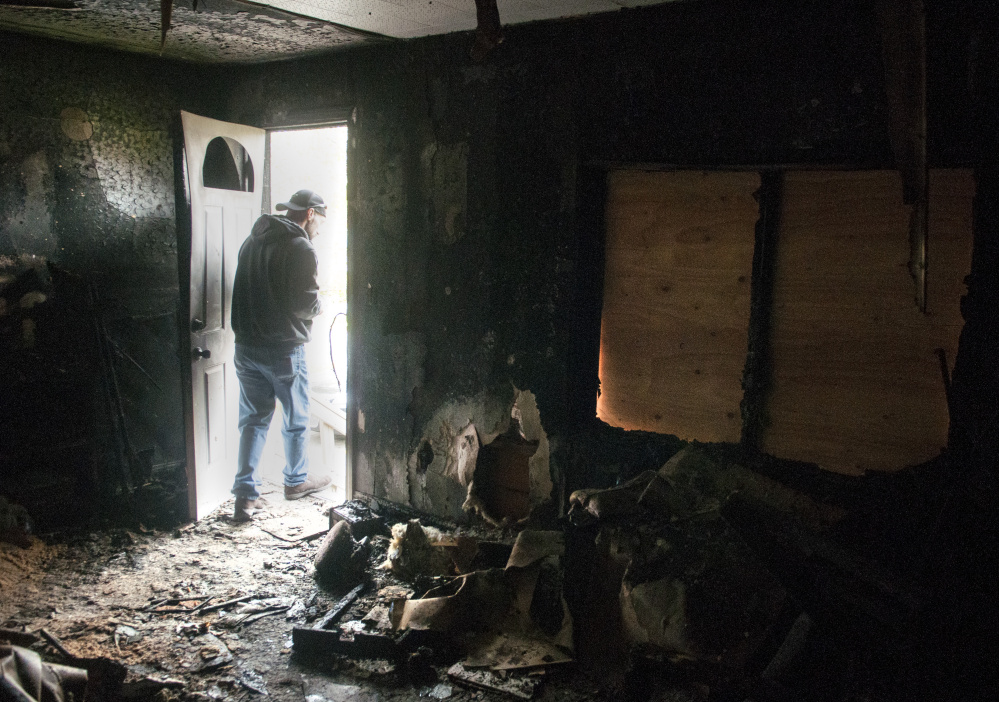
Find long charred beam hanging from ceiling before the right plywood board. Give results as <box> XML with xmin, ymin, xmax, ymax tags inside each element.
<box><xmin>878</xmin><ymin>0</ymin><xmax>929</xmax><ymax>314</ymax></box>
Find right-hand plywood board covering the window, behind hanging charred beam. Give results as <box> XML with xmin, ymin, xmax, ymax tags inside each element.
<box><xmin>763</xmin><ymin>170</ymin><xmax>974</xmax><ymax>474</ymax></box>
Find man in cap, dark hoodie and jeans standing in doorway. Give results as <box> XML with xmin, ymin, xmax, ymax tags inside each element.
<box><xmin>232</xmin><ymin>190</ymin><xmax>330</xmax><ymax>522</ymax></box>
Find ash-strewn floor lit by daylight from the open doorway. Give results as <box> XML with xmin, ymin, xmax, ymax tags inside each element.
<box><xmin>0</xmin><ymin>492</ymin><xmax>616</xmax><ymax>702</ymax></box>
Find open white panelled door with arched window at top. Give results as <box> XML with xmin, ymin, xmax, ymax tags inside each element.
<box><xmin>181</xmin><ymin>112</ymin><xmax>265</xmax><ymax>519</ymax></box>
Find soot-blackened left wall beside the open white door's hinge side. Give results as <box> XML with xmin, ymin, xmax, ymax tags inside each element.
<box><xmin>0</xmin><ymin>35</ymin><xmax>225</xmax><ymax>524</ymax></box>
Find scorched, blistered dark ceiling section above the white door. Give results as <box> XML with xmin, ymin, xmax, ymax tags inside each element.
<box><xmin>0</xmin><ymin>0</ymin><xmax>381</xmax><ymax>63</ymax></box>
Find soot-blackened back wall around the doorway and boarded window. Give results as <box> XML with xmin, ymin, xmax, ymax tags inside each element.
<box><xmin>230</xmin><ymin>1</ymin><xmax>992</xmax><ymax>515</ymax></box>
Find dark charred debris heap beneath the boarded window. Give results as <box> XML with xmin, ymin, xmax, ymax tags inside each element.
<box><xmin>570</xmin><ymin>448</ymin><xmax>808</xmax><ymax>676</ymax></box>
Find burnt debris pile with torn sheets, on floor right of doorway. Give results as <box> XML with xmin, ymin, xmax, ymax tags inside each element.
<box><xmin>293</xmin><ymin>506</ymin><xmax>573</xmax><ymax>697</ymax></box>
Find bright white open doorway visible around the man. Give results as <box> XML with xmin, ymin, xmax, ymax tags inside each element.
<box><xmin>260</xmin><ymin>124</ymin><xmax>353</xmax><ymax>503</ymax></box>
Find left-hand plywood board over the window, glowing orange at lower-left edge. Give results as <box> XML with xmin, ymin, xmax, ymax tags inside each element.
<box><xmin>597</xmin><ymin>171</ymin><xmax>760</xmax><ymax>441</ymax></box>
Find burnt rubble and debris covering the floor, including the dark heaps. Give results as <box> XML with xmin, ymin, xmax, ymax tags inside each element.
<box><xmin>0</xmin><ymin>447</ymin><xmax>968</xmax><ymax>702</ymax></box>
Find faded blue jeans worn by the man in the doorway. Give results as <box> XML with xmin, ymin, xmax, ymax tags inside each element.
<box><xmin>232</xmin><ymin>344</ymin><xmax>309</xmax><ymax>500</ymax></box>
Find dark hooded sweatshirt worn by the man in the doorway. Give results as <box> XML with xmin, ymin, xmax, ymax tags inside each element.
<box><xmin>232</xmin><ymin>215</ymin><xmax>322</xmax><ymax>352</ymax></box>
